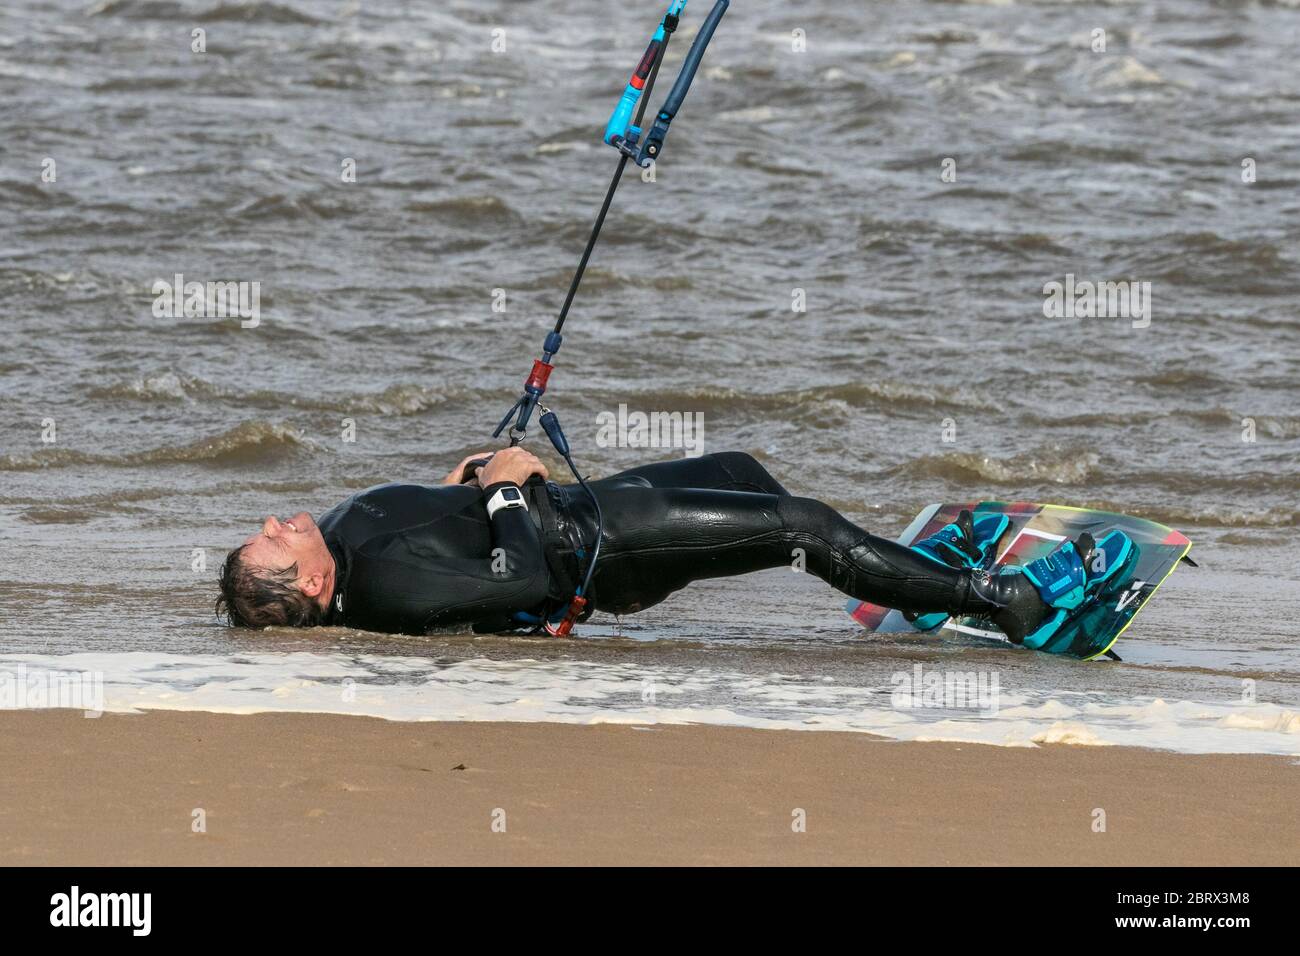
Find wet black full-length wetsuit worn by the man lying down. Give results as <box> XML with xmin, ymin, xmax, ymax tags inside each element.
<box><xmin>319</xmin><ymin>453</ymin><xmax>991</xmax><ymax>633</ymax></box>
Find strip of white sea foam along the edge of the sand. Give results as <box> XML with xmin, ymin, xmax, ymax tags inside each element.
<box><xmin>0</xmin><ymin>653</ymin><xmax>1300</xmax><ymax>756</ymax></box>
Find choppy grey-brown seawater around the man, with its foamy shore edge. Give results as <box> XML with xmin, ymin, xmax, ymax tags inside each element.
<box><xmin>0</xmin><ymin>0</ymin><xmax>1300</xmax><ymax>753</ymax></box>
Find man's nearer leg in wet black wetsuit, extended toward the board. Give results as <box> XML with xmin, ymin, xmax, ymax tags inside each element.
<box><xmin>594</xmin><ymin>486</ymin><xmax>993</xmax><ymax>614</ymax></box>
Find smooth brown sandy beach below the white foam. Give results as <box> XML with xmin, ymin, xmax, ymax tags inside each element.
<box><xmin>0</xmin><ymin>710</ymin><xmax>1300</xmax><ymax>865</ymax></box>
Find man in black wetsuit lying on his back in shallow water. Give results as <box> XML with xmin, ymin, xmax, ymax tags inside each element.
<box><xmin>217</xmin><ymin>447</ymin><xmax>1088</xmax><ymax>646</ymax></box>
